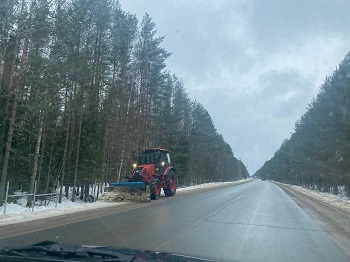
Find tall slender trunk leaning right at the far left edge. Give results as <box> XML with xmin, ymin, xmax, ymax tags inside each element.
<box><xmin>0</xmin><ymin>1</ymin><xmax>33</xmax><ymax>206</ymax></box>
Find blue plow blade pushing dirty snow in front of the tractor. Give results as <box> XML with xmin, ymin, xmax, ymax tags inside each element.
<box><xmin>100</xmin><ymin>182</ymin><xmax>150</xmax><ymax>202</ymax></box>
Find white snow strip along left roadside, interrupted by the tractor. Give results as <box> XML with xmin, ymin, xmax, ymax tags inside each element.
<box><xmin>0</xmin><ymin>179</ymin><xmax>250</xmax><ymax>226</ymax></box>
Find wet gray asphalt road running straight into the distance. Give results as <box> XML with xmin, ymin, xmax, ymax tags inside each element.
<box><xmin>0</xmin><ymin>180</ymin><xmax>350</xmax><ymax>261</ymax></box>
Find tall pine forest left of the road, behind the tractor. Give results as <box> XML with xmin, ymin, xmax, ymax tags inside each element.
<box><xmin>0</xmin><ymin>0</ymin><xmax>248</xmax><ymax>205</ymax></box>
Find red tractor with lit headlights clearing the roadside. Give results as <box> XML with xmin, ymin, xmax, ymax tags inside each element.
<box><xmin>108</xmin><ymin>148</ymin><xmax>176</xmax><ymax>199</ymax></box>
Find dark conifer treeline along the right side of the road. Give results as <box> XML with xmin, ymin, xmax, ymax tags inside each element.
<box><xmin>256</xmin><ymin>53</ymin><xmax>350</xmax><ymax>196</ymax></box>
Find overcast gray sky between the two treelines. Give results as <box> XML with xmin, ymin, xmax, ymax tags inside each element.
<box><xmin>120</xmin><ymin>0</ymin><xmax>350</xmax><ymax>175</ymax></box>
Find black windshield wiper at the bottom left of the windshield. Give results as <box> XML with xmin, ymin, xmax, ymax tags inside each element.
<box><xmin>0</xmin><ymin>241</ymin><xmax>136</xmax><ymax>262</ymax></box>
